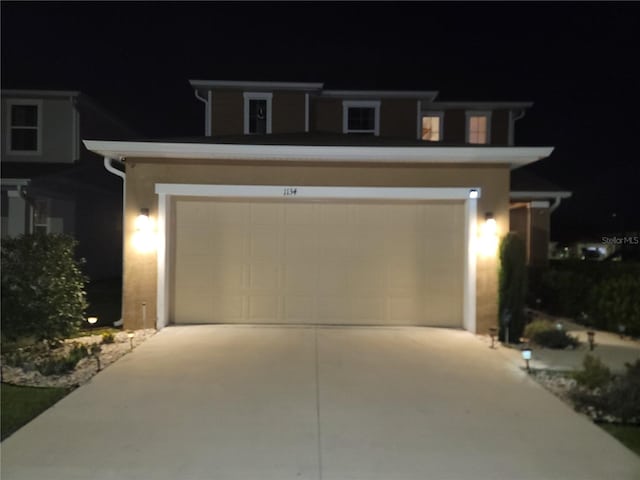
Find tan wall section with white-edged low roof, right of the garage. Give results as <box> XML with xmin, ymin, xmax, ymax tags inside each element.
<box><xmin>509</xmin><ymin>169</ymin><xmax>571</xmax><ymax>266</ymax></box>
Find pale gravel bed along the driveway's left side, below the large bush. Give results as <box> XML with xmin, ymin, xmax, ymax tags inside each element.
<box><xmin>1</xmin><ymin>329</ymin><xmax>156</xmax><ymax>387</ymax></box>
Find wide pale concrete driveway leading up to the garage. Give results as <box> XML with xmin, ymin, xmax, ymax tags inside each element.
<box><xmin>2</xmin><ymin>326</ymin><xmax>640</xmax><ymax>480</ymax></box>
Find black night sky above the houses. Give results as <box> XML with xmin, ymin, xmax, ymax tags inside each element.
<box><xmin>1</xmin><ymin>2</ymin><xmax>640</xmax><ymax>239</ymax></box>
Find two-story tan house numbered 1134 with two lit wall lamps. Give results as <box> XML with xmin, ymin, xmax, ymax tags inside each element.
<box><xmin>85</xmin><ymin>80</ymin><xmax>552</xmax><ymax>332</ymax></box>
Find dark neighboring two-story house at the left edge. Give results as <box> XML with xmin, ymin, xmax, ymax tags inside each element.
<box><xmin>1</xmin><ymin>90</ymin><xmax>136</xmax><ymax>279</ymax></box>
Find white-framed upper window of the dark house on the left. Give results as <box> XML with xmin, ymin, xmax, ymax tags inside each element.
<box><xmin>7</xmin><ymin>99</ymin><xmax>42</xmax><ymax>155</ymax></box>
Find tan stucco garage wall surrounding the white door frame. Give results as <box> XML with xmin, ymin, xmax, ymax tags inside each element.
<box><xmin>124</xmin><ymin>159</ymin><xmax>509</xmax><ymax>332</ymax></box>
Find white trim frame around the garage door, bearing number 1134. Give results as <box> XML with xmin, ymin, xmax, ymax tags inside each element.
<box><xmin>155</xmin><ymin>183</ymin><xmax>481</xmax><ymax>332</ymax></box>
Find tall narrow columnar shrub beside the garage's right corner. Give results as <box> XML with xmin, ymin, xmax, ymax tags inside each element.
<box><xmin>498</xmin><ymin>233</ymin><xmax>527</xmax><ymax>341</ymax></box>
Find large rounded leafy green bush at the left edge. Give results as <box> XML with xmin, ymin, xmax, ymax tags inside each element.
<box><xmin>1</xmin><ymin>234</ymin><xmax>87</xmax><ymax>340</ymax></box>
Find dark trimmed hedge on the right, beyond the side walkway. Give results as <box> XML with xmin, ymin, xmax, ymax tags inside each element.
<box><xmin>527</xmin><ymin>261</ymin><xmax>640</xmax><ymax>336</ymax></box>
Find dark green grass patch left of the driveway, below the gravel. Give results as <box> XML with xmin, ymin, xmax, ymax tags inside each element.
<box><xmin>0</xmin><ymin>383</ymin><xmax>71</xmax><ymax>440</ymax></box>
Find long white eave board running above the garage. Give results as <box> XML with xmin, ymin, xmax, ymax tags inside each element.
<box><xmin>84</xmin><ymin>140</ymin><xmax>553</xmax><ymax>168</ymax></box>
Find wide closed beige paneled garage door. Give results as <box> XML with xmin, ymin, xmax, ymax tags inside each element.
<box><xmin>171</xmin><ymin>198</ymin><xmax>465</xmax><ymax>327</ymax></box>
